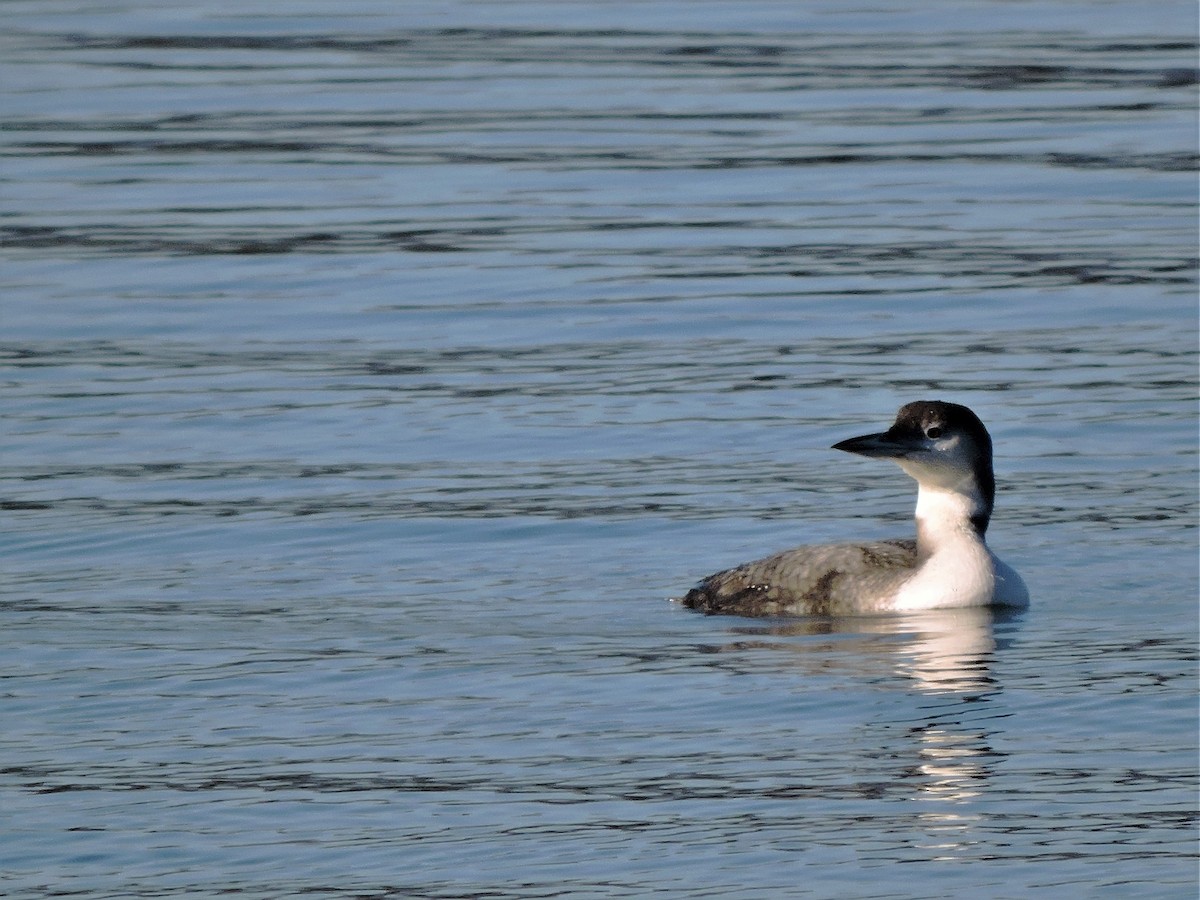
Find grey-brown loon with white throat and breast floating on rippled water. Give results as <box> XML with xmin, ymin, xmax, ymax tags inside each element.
<box><xmin>683</xmin><ymin>400</ymin><xmax>1030</xmax><ymax>616</ymax></box>
